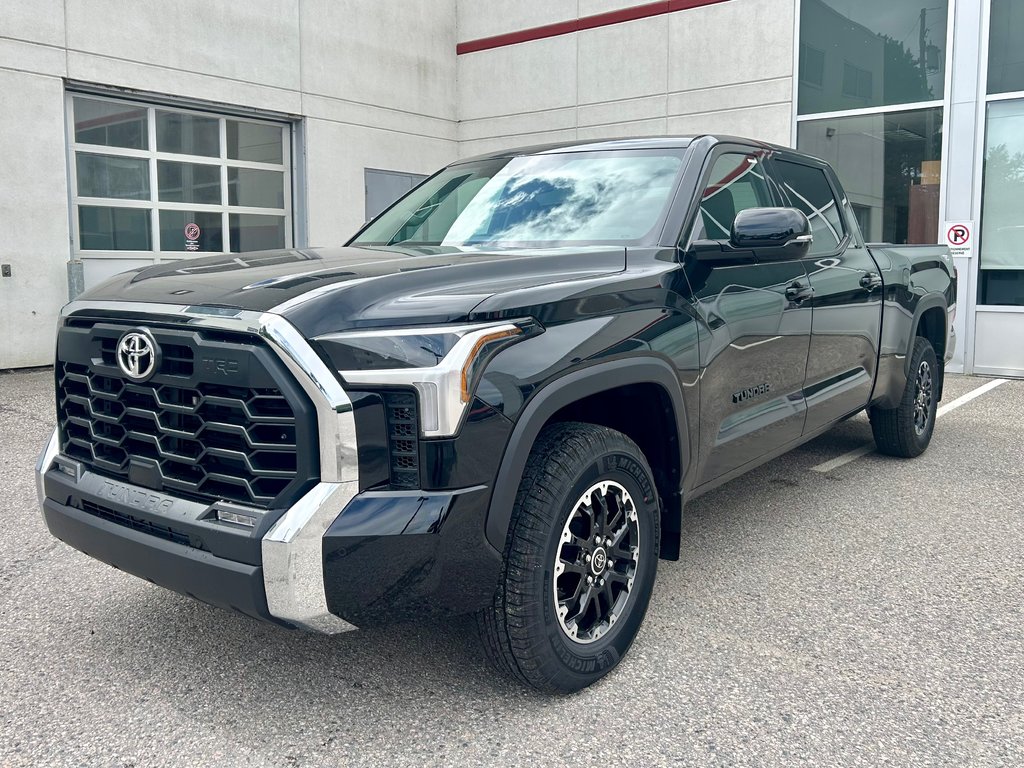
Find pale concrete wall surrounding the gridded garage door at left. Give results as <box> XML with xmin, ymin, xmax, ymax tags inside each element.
<box><xmin>0</xmin><ymin>0</ymin><xmax>458</xmax><ymax>369</ymax></box>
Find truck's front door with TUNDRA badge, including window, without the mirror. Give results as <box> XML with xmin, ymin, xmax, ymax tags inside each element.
<box><xmin>685</xmin><ymin>153</ymin><xmax>811</xmax><ymax>484</ymax></box>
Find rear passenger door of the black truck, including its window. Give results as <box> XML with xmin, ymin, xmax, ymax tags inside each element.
<box><xmin>771</xmin><ymin>156</ymin><xmax>882</xmax><ymax>433</ymax></box>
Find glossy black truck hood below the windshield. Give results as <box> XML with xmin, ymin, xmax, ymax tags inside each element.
<box><xmin>80</xmin><ymin>246</ymin><xmax>626</xmax><ymax>336</ymax></box>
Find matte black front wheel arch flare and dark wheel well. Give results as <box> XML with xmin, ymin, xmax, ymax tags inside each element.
<box><xmin>485</xmin><ymin>357</ymin><xmax>690</xmax><ymax>559</ymax></box>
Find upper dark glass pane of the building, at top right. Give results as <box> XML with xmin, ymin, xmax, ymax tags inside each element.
<box><xmin>798</xmin><ymin>0</ymin><xmax>946</xmax><ymax>115</ymax></box>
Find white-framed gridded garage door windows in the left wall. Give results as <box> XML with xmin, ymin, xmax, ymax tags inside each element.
<box><xmin>68</xmin><ymin>93</ymin><xmax>292</xmax><ymax>261</ymax></box>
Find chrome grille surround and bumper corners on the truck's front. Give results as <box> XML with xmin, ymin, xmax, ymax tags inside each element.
<box><xmin>36</xmin><ymin>301</ymin><xmax>359</xmax><ymax>633</ymax></box>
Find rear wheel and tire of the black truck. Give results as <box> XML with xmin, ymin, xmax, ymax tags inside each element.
<box><xmin>868</xmin><ymin>336</ymin><xmax>941</xmax><ymax>459</ymax></box>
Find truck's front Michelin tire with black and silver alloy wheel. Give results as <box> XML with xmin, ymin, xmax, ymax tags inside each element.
<box><xmin>477</xmin><ymin>422</ymin><xmax>660</xmax><ymax>693</ymax></box>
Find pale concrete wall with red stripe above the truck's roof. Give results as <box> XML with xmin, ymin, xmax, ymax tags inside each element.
<box><xmin>457</xmin><ymin>0</ymin><xmax>796</xmax><ymax>156</ymax></box>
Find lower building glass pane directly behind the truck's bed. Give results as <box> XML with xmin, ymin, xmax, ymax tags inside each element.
<box><xmin>797</xmin><ymin>106</ymin><xmax>942</xmax><ymax>244</ymax></box>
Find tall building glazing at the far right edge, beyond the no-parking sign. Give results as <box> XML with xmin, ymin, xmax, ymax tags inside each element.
<box><xmin>978</xmin><ymin>0</ymin><xmax>1024</xmax><ymax>306</ymax></box>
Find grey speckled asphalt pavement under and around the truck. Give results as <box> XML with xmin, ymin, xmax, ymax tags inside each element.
<box><xmin>0</xmin><ymin>370</ymin><xmax>1024</xmax><ymax>768</ymax></box>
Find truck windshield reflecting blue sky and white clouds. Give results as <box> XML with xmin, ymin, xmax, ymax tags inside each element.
<box><xmin>352</xmin><ymin>148</ymin><xmax>683</xmax><ymax>247</ymax></box>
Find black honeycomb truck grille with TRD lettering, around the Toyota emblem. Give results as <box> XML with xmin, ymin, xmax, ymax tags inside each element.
<box><xmin>56</xmin><ymin>323</ymin><xmax>316</xmax><ymax>508</ymax></box>
